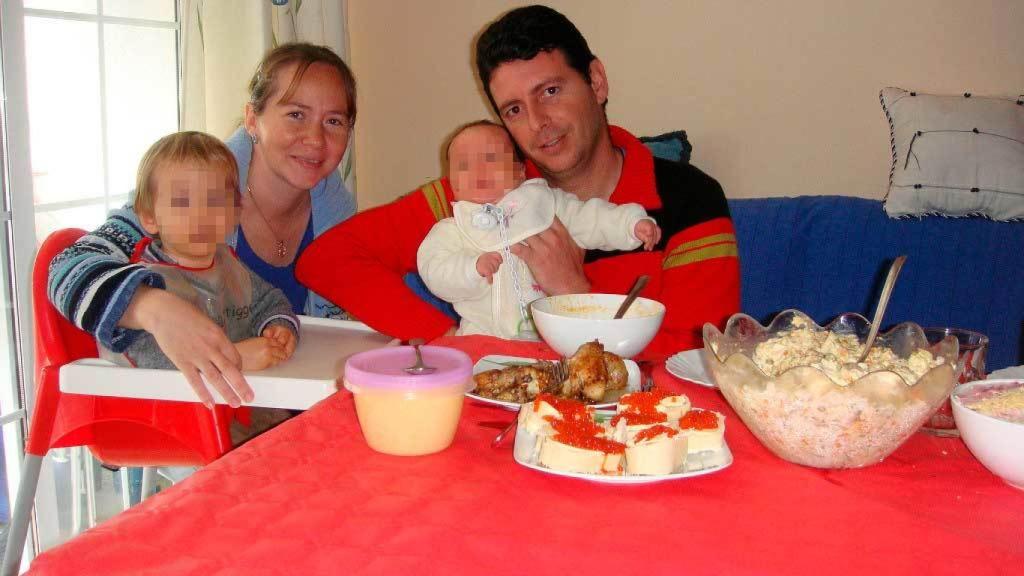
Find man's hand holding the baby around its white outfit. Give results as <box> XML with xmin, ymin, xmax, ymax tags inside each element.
<box><xmin>510</xmin><ymin>217</ymin><xmax>590</xmax><ymax>295</ymax></box>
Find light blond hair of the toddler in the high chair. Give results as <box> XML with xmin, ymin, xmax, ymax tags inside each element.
<box><xmin>132</xmin><ymin>131</ymin><xmax>240</xmax><ymax>214</ymax></box>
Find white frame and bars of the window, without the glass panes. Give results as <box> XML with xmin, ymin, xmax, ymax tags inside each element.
<box><xmin>0</xmin><ymin>0</ymin><xmax>187</xmax><ymax>567</ymax></box>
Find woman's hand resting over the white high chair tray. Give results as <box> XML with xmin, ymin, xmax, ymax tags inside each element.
<box><xmin>119</xmin><ymin>286</ymin><xmax>253</xmax><ymax>408</ymax></box>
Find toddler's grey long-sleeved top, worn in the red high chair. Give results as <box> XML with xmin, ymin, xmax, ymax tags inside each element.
<box><xmin>99</xmin><ymin>241</ymin><xmax>299</xmax><ymax>370</ymax></box>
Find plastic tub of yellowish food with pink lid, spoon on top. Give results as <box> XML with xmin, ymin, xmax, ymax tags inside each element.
<box><xmin>344</xmin><ymin>346</ymin><xmax>474</xmax><ymax>456</ymax></box>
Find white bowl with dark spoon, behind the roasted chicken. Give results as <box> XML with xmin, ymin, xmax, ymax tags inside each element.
<box><xmin>530</xmin><ymin>294</ymin><xmax>665</xmax><ymax>358</ymax></box>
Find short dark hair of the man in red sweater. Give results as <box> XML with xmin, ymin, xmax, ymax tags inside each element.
<box><xmin>476</xmin><ymin>5</ymin><xmax>597</xmax><ymax>115</ymax></box>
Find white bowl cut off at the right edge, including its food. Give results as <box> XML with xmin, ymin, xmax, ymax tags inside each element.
<box><xmin>950</xmin><ymin>379</ymin><xmax>1024</xmax><ymax>490</ymax></box>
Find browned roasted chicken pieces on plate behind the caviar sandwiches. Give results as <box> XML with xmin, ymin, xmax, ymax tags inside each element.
<box><xmin>473</xmin><ymin>340</ymin><xmax>629</xmax><ymax>403</ymax></box>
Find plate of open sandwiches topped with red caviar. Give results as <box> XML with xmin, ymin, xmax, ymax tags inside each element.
<box><xmin>514</xmin><ymin>390</ymin><xmax>732</xmax><ymax>484</ymax></box>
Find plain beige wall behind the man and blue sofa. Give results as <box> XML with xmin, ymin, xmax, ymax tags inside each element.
<box><xmin>348</xmin><ymin>0</ymin><xmax>1024</xmax><ymax>208</ymax></box>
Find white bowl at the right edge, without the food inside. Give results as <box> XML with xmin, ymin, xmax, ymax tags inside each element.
<box><xmin>950</xmin><ymin>380</ymin><xmax>1024</xmax><ymax>490</ymax></box>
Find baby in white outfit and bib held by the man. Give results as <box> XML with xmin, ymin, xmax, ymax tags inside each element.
<box><xmin>417</xmin><ymin>121</ymin><xmax>662</xmax><ymax>338</ymax></box>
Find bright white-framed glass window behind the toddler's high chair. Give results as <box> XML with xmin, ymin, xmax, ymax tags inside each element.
<box><xmin>0</xmin><ymin>0</ymin><xmax>179</xmax><ymax>565</ymax></box>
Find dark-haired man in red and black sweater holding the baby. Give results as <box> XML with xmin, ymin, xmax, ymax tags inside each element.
<box><xmin>296</xmin><ymin>6</ymin><xmax>739</xmax><ymax>357</ymax></box>
